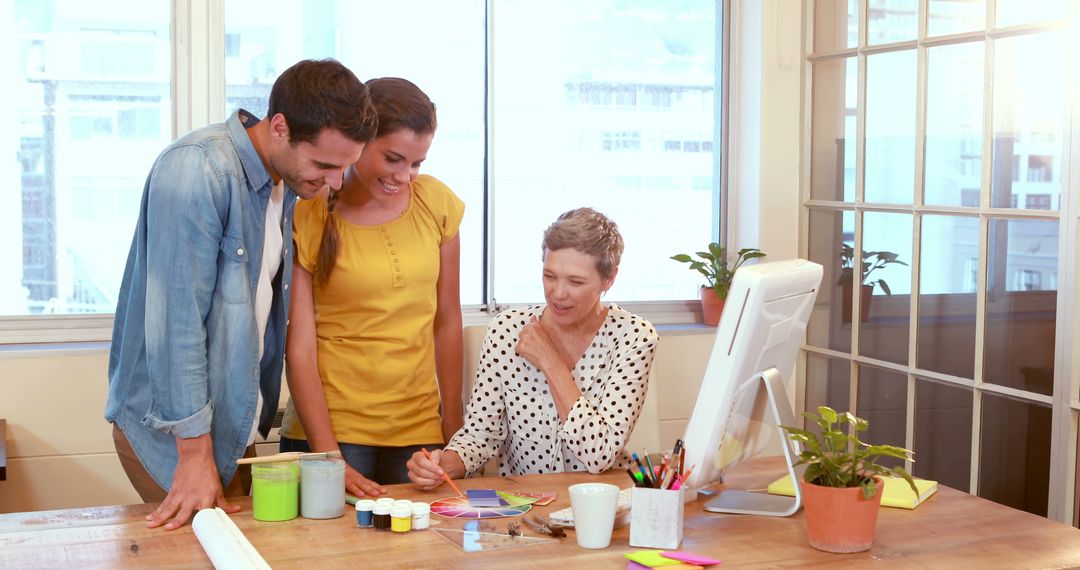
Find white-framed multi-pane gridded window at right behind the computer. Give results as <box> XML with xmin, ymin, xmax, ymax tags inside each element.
<box><xmin>804</xmin><ymin>0</ymin><xmax>1080</xmax><ymax>520</ymax></box>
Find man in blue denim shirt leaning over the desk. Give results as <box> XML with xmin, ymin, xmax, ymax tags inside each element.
<box><xmin>105</xmin><ymin>59</ymin><xmax>377</xmax><ymax>529</ymax></box>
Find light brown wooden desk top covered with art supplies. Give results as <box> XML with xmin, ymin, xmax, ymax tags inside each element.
<box><xmin>0</xmin><ymin>458</ymin><xmax>1080</xmax><ymax>570</ymax></box>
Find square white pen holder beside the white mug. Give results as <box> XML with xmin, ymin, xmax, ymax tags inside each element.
<box><xmin>630</xmin><ymin>487</ymin><xmax>683</xmax><ymax>549</ymax></box>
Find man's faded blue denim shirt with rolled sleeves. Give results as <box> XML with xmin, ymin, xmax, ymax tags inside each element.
<box><xmin>105</xmin><ymin>110</ymin><xmax>297</xmax><ymax>491</ymax></box>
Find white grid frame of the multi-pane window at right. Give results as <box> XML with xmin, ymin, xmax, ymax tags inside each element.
<box><xmin>797</xmin><ymin>0</ymin><xmax>1080</xmax><ymax>523</ymax></box>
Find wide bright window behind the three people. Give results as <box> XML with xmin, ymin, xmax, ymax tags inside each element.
<box><xmin>0</xmin><ymin>0</ymin><xmax>723</xmax><ymax>334</ymax></box>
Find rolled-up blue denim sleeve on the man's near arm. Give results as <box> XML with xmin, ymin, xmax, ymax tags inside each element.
<box><xmin>143</xmin><ymin>146</ymin><xmax>228</xmax><ymax>437</ymax></box>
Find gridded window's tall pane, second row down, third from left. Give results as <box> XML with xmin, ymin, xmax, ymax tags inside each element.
<box><xmin>924</xmin><ymin>42</ymin><xmax>983</xmax><ymax>207</ymax></box>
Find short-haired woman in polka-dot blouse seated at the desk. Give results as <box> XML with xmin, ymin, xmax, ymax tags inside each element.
<box><xmin>408</xmin><ymin>208</ymin><xmax>658</xmax><ymax>489</ymax></box>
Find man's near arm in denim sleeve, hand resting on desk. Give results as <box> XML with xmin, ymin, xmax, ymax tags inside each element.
<box><xmin>145</xmin><ymin>146</ymin><xmax>237</xmax><ymax>530</ymax></box>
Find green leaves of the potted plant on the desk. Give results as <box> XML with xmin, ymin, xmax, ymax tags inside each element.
<box><xmin>780</xmin><ymin>406</ymin><xmax>919</xmax><ymax>499</ymax></box>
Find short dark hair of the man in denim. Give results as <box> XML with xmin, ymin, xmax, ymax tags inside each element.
<box><xmin>267</xmin><ymin>59</ymin><xmax>379</xmax><ymax>145</ymax></box>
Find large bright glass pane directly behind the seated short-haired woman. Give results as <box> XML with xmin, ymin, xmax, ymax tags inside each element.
<box><xmin>494</xmin><ymin>0</ymin><xmax>721</xmax><ymax>302</ymax></box>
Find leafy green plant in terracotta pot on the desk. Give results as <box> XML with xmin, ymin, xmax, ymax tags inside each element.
<box><xmin>780</xmin><ymin>406</ymin><xmax>919</xmax><ymax>553</ymax></box>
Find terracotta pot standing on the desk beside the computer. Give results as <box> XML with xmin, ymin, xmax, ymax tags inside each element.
<box><xmin>799</xmin><ymin>477</ymin><xmax>885</xmax><ymax>553</ymax></box>
